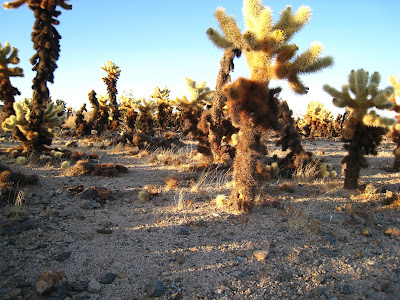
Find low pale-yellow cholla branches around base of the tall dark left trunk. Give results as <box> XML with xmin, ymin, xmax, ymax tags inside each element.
<box><xmin>1</xmin><ymin>98</ymin><xmax>65</xmax><ymax>147</ymax></box>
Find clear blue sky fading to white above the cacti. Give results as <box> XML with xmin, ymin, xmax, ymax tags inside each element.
<box><xmin>0</xmin><ymin>0</ymin><xmax>400</xmax><ymax>114</ymax></box>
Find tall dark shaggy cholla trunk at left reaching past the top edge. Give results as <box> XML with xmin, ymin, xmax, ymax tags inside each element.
<box><xmin>3</xmin><ymin>0</ymin><xmax>72</xmax><ymax>153</ymax></box>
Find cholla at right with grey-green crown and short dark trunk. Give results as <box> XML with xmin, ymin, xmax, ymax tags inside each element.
<box><xmin>324</xmin><ymin>69</ymin><xmax>394</xmax><ymax>189</ymax></box>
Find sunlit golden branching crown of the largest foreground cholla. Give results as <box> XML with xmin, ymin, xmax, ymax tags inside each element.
<box><xmin>207</xmin><ymin>0</ymin><xmax>333</xmax><ymax>94</ymax></box>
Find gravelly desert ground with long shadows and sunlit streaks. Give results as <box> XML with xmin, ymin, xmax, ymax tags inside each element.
<box><xmin>0</xmin><ymin>137</ymin><xmax>400</xmax><ymax>300</ymax></box>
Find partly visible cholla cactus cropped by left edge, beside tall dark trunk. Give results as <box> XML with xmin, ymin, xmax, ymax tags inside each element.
<box><xmin>0</xmin><ymin>42</ymin><xmax>24</xmax><ymax>122</ymax></box>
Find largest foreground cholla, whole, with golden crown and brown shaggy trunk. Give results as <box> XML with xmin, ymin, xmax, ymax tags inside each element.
<box><xmin>207</xmin><ymin>0</ymin><xmax>333</xmax><ymax>211</ymax></box>
